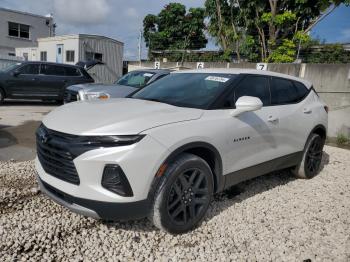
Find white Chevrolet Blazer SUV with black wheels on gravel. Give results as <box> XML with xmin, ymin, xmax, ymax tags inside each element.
<box><xmin>36</xmin><ymin>69</ymin><xmax>328</xmax><ymax>233</ymax></box>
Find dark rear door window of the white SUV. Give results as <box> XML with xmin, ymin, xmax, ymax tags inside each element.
<box><xmin>271</xmin><ymin>77</ymin><xmax>299</xmax><ymax>105</ymax></box>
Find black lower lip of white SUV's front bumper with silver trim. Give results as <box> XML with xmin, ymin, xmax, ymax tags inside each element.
<box><xmin>37</xmin><ymin>176</ymin><xmax>150</xmax><ymax>220</ymax></box>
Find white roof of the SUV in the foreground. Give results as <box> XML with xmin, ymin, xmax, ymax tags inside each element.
<box><xmin>171</xmin><ymin>68</ymin><xmax>312</xmax><ymax>88</ymax></box>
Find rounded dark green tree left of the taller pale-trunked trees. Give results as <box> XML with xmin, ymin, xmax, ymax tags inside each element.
<box><xmin>143</xmin><ymin>3</ymin><xmax>207</xmax><ymax>60</ymax></box>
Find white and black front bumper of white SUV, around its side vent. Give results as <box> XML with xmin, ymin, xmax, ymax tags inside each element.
<box><xmin>35</xmin><ymin>133</ymin><xmax>168</xmax><ymax>220</ymax></box>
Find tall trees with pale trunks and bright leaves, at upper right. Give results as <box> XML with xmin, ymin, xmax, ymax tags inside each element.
<box><xmin>205</xmin><ymin>0</ymin><xmax>350</xmax><ymax>62</ymax></box>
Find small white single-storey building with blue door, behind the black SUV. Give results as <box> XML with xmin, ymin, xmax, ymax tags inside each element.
<box><xmin>16</xmin><ymin>34</ymin><xmax>124</xmax><ymax>83</ymax></box>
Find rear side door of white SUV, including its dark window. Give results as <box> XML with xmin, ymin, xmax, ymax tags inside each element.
<box><xmin>271</xmin><ymin>77</ymin><xmax>313</xmax><ymax>155</ymax></box>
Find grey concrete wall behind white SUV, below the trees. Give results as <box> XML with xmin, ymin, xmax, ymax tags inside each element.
<box><xmin>129</xmin><ymin>62</ymin><xmax>350</xmax><ymax>137</ymax></box>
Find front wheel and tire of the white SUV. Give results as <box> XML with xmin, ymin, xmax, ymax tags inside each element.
<box><xmin>149</xmin><ymin>153</ymin><xmax>214</xmax><ymax>234</ymax></box>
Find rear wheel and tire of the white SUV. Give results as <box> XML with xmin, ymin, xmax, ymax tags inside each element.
<box><xmin>292</xmin><ymin>134</ymin><xmax>325</xmax><ymax>179</ymax></box>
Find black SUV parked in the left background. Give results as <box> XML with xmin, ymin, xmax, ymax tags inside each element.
<box><xmin>0</xmin><ymin>62</ymin><xmax>94</xmax><ymax>103</ymax></box>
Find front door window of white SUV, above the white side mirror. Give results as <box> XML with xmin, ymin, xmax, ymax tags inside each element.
<box><xmin>235</xmin><ymin>76</ymin><xmax>271</xmax><ymax>106</ymax></box>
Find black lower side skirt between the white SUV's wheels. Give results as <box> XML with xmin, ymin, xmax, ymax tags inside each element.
<box><xmin>224</xmin><ymin>151</ymin><xmax>303</xmax><ymax>188</ymax></box>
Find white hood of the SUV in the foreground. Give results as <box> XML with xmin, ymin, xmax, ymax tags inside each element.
<box><xmin>43</xmin><ymin>98</ymin><xmax>203</xmax><ymax>135</ymax></box>
